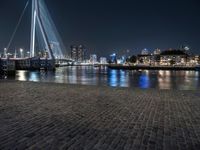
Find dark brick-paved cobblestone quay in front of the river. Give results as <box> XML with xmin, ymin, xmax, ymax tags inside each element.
<box><xmin>0</xmin><ymin>81</ymin><xmax>200</xmax><ymax>150</ymax></box>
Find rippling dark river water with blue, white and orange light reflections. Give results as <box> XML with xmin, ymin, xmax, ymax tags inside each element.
<box><xmin>10</xmin><ymin>67</ymin><xmax>200</xmax><ymax>90</ymax></box>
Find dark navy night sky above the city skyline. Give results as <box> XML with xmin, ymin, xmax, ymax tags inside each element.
<box><xmin>0</xmin><ymin>0</ymin><xmax>200</xmax><ymax>56</ymax></box>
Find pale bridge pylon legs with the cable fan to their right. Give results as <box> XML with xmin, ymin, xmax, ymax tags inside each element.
<box><xmin>30</xmin><ymin>0</ymin><xmax>65</xmax><ymax>59</ymax></box>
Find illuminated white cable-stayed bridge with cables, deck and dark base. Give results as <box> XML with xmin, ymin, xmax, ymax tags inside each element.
<box><xmin>0</xmin><ymin>0</ymin><xmax>73</xmax><ymax>72</ymax></box>
